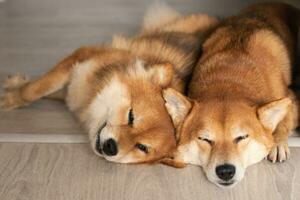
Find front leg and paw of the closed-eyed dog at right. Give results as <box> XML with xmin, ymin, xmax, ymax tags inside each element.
<box><xmin>268</xmin><ymin>92</ymin><xmax>298</xmax><ymax>163</ymax></box>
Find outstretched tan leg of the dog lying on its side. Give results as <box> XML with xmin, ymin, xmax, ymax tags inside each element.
<box><xmin>0</xmin><ymin>47</ymin><xmax>101</xmax><ymax>110</ymax></box>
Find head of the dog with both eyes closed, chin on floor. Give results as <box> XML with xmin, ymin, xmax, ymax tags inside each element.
<box><xmin>164</xmin><ymin>89</ymin><xmax>291</xmax><ymax>187</ymax></box>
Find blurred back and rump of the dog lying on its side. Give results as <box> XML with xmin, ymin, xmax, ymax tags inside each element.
<box><xmin>112</xmin><ymin>6</ymin><xmax>218</xmax><ymax>92</ymax></box>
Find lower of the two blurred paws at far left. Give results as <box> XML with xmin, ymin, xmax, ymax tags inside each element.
<box><xmin>0</xmin><ymin>89</ymin><xmax>28</xmax><ymax>110</ymax></box>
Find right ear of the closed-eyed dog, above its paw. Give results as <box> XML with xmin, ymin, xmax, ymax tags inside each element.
<box><xmin>257</xmin><ymin>98</ymin><xmax>292</xmax><ymax>131</ymax></box>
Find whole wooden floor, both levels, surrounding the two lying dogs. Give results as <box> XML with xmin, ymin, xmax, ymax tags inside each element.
<box><xmin>0</xmin><ymin>0</ymin><xmax>300</xmax><ymax>200</ymax></box>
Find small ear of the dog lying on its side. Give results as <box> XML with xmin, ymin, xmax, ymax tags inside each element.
<box><xmin>149</xmin><ymin>63</ymin><xmax>174</xmax><ymax>88</ymax></box>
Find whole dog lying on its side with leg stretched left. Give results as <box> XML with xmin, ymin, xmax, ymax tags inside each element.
<box><xmin>1</xmin><ymin>4</ymin><xmax>217</xmax><ymax>163</ymax></box>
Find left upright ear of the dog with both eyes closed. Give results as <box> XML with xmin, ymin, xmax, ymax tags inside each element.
<box><xmin>163</xmin><ymin>88</ymin><xmax>192</xmax><ymax>127</ymax></box>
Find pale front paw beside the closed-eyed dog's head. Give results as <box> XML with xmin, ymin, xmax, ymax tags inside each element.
<box><xmin>268</xmin><ymin>142</ymin><xmax>290</xmax><ymax>163</ymax></box>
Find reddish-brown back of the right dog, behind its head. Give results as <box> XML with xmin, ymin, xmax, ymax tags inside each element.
<box><xmin>189</xmin><ymin>1</ymin><xmax>298</xmax><ymax>103</ymax></box>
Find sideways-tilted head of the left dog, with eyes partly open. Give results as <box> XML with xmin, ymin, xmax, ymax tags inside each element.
<box><xmin>82</xmin><ymin>59</ymin><xmax>176</xmax><ymax>163</ymax></box>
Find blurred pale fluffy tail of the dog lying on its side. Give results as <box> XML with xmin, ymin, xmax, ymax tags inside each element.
<box><xmin>142</xmin><ymin>2</ymin><xmax>181</xmax><ymax>31</ymax></box>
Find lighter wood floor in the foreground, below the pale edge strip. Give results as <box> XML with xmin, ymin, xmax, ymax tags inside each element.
<box><xmin>0</xmin><ymin>143</ymin><xmax>300</xmax><ymax>200</ymax></box>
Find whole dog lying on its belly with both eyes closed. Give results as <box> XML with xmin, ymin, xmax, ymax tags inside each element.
<box><xmin>164</xmin><ymin>3</ymin><xmax>300</xmax><ymax>186</ymax></box>
